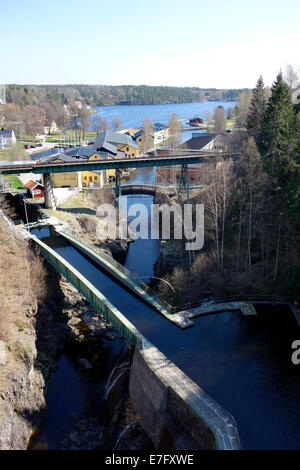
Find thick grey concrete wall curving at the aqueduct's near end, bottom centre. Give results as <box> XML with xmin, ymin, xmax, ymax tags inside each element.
<box><xmin>130</xmin><ymin>338</ymin><xmax>240</xmax><ymax>450</ymax></box>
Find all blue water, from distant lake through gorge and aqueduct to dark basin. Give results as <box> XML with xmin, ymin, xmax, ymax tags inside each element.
<box><xmin>25</xmin><ymin>103</ymin><xmax>300</xmax><ymax>449</ymax></box>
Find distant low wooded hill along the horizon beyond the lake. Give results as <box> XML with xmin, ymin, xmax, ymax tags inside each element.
<box><xmin>6</xmin><ymin>84</ymin><xmax>242</xmax><ymax>106</ymax></box>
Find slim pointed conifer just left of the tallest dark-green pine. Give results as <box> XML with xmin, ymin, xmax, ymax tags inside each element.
<box><xmin>247</xmin><ymin>76</ymin><xmax>267</xmax><ymax>144</ymax></box>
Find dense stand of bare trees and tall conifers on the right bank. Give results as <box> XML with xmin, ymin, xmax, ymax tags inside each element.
<box><xmin>156</xmin><ymin>73</ymin><xmax>300</xmax><ymax>304</ymax></box>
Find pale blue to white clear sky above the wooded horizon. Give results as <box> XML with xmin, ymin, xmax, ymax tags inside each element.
<box><xmin>0</xmin><ymin>0</ymin><xmax>300</xmax><ymax>88</ymax></box>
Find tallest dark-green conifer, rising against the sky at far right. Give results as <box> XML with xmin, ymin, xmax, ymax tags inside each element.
<box><xmin>261</xmin><ymin>73</ymin><xmax>295</xmax><ymax>187</ymax></box>
